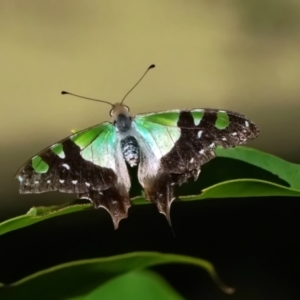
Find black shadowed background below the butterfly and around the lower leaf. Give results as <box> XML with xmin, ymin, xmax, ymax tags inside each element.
<box><xmin>0</xmin><ymin>197</ymin><xmax>300</xmax><ymax>300</ymax></box>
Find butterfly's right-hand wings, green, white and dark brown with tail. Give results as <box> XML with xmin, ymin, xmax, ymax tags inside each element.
<box><xmin>133</xmin><ymin>109</ymin><xmax>259</xmax><ymax>221</ymax></box>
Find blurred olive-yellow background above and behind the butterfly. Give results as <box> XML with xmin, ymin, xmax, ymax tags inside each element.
<box><xmin>0</xmin><ymin>0</ymin><xmax>300</xmax><ymax>216</ymax></box>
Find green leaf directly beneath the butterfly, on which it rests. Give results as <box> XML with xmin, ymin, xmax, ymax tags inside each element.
<box><xmin>0</xmin><ymin>147</ymin><xmax>300</xmax><ymax>235</ymax></box>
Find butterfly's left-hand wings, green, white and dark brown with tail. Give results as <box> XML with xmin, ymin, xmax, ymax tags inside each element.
<box><xmin>16</xmin><ymin>122</ymin><xmax>130</xmax><ymax>228</ymax></box>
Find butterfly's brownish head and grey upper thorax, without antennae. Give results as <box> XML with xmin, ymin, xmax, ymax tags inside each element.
<box><xmin>109</xmin><ymin>103</ymin><xmax>132</xmax><ymax>133</ymax></box>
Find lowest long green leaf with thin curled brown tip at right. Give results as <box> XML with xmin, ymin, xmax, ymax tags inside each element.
<box><xmin>0</xmin><ymin>252</ymin><xmax>234</xmax><ymax>300</ymax></box>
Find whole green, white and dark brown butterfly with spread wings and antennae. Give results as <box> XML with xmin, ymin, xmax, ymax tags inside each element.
<box><xmin>16</xmin><ymin>65</ymin><xmax>259</xmax><ymax>229</ymax></box>
